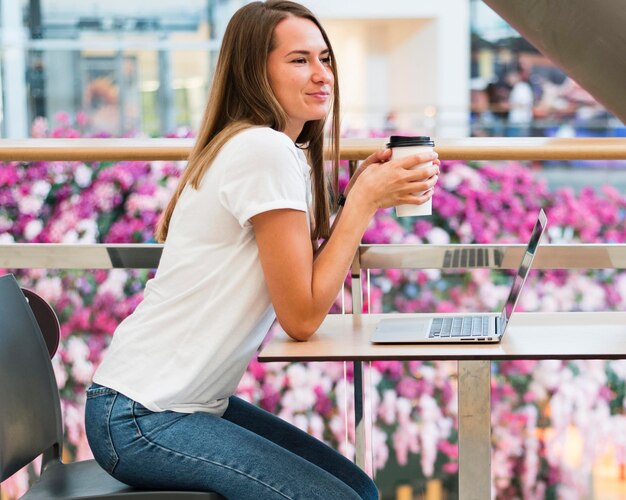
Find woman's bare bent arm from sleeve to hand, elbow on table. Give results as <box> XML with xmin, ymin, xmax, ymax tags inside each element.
<box><xmin>252</xmin><ymin>153</ymin><xmax>439</xmax><ymax>340</ymax></box>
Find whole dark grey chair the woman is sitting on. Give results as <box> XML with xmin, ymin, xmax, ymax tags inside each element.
<box><xmin>0</xmin><ymin>274</ymin><xmax>223</xmax><ymax>500</ymax></box>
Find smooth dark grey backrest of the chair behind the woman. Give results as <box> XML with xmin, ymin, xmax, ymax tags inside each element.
<box><xmin>0</xmin><ymin>274</ymin><xmax>63</xmax><ymax>481</ymax></box>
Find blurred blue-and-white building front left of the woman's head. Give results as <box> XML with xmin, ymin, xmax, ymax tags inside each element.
<box><xmin>0</xmin><ymin>0</ymin><xmax>222</xmax><ymax>137</ymax></box>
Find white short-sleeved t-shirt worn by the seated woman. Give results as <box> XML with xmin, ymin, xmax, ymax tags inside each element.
<box><xmin>94</xmin><ymin>127</ymin><xmax>311</xmax><ymax>415</ymax></box>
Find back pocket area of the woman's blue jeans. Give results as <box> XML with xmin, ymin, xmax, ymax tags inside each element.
<box><xmin>85</xmin><ymin>386</ymin><xmax>119</xmax><ymax>474</ymax></box>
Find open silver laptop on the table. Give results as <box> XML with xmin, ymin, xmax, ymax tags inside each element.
<box><xmin>371</xmin><ymin>210</ymin><xmax>547</xmax><ymax>344</ymax></box>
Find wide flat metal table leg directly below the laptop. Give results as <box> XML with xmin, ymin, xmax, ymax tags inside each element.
<box><xmin>458</xmin><ymin>361</ymin><xmax>491</xmax><ymax>500</ymax></box>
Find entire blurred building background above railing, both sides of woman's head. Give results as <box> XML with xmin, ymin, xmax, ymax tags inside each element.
<box><xmin>0</xmin><ymin>0</ymin><xmax>626</xmax><ymax>138</ymax></box>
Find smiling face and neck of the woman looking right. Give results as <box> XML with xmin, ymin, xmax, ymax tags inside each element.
<box><xmin>267</xmin><ymin>17</ymin><xmax>334</xmax><ymax>142</ymax></box>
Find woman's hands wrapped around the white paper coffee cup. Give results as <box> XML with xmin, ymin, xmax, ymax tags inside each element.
<box><xmin>346</xmin><ymin>150</ymin><xmax>440</xmax><ymax>215</ymax></box>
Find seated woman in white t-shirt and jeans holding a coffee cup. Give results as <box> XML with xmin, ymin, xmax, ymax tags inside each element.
<box><xmin>86</xmin><ymin>1</ymin><xmax>438</xmax><ymax>500</ymax></box>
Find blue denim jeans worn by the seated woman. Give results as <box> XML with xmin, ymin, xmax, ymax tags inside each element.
<box><xmin>85</xmin><ymin>384</ymin><xmax>378</xmax><ymax>500</ymax></box>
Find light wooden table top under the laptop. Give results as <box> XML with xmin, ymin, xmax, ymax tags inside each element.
<box><xmin>259</xmin><ymin>312</ymin><xmax>626</xmax><ymax>362</ymax></box>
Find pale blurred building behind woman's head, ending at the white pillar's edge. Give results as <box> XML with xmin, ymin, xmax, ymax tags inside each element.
<box><xmin>0</xmin><ymin>0</ymin><xmax>470</xmax><ymax>137</ymax></box>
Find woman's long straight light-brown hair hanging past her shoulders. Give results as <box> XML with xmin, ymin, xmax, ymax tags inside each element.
<box><xmin>156</xmin><ymin>0</ymin><xmax>339</xmax><ymax>242</ymax></box>
